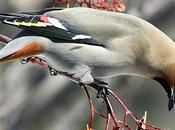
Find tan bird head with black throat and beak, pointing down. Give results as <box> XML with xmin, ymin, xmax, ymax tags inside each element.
<box><xmin>147</xmin><ymin>37</ymin><xmax>175</xmax><ymax>111</ymax></box>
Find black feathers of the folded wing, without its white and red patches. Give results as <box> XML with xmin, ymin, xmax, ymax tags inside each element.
<box><xmin>0</xmin><ymin>8</ymin><xmax>103</xmax><ymax>46</ymax></box>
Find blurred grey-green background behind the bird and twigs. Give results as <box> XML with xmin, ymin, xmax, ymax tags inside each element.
<box><xmin>0</xmin><ymin>0</ymin><xmax>175</xmax><ymax>130</ymax></box>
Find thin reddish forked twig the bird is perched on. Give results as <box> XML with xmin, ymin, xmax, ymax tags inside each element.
<box><xmin>39</xmin><ymin>66</ymin><xmax>161</xmax><ymax>130</ymax></box>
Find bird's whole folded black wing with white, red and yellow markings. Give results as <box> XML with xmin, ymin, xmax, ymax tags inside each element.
<box><xmin>0</xmin><ymin>9</ymin><xmax>102</xmax><ymax>46</ymax></box>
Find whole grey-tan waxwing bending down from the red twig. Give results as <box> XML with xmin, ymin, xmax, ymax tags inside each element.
<box><xmin>0</xmin><ymin>8</ymin><xmax>175</xmax><ymax>110</ymax></box>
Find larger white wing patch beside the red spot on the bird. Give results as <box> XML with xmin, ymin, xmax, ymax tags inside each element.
<box><xmin>48</xmin><ymin>17</ymin><xmax>67</xmax><ymax>31</ymax></box>
